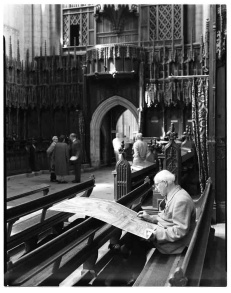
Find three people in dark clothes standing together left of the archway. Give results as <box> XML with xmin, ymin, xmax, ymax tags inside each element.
<box><xmin>47</xmin><ymin>133</ymin><xmax>81</xmax><ymax>183</ymax></box>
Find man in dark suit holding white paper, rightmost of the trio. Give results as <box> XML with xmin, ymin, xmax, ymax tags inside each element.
<box><xmin>70</xmin><ymin>133</ymin><xmax>82</xmax><ymax>183</ymax></box>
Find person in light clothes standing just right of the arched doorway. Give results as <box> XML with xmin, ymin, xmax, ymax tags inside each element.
<box><xmin>133</xmin><ymin>133</ymin><xmax>148</xmax><ymax>165</ymax></box>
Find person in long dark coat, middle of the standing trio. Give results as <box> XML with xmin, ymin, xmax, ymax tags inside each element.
<box><xmin>54</xmin><ymin>135</ymin><xmax>69</xmax><ymax>183</ymax></box>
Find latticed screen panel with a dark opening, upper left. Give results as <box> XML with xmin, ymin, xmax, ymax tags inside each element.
<box><xmin>63</xmin><ymin>4</ymin><xmax>94</xmax><ymax>47</ymax></box>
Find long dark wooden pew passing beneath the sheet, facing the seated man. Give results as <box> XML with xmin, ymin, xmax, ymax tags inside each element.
<box><xmin>4</xmin><ymin>179</ymin><xmax>151</xmax><ymax>286</ymax></box>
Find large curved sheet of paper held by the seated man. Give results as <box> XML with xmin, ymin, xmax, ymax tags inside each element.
<box><xmin>49</xmin><ymin>197</ymin><xmax>156</xmax><ymax>239</ymax></box>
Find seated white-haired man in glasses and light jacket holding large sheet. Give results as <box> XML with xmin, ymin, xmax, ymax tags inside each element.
<box><xmin>137</xmin><ymin>170</ymin><xmax>196</xmax><ymax>254</ymax></box>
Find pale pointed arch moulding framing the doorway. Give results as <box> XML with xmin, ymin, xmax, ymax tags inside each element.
<box><xmin>90</xmin><ymin>96</ymin><xmax>138</xmax><ymax>168</ymax></box>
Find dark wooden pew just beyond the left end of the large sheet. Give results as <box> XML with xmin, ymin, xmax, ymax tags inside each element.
<box><xmin>6</xmin><ymin>176</ymin><xmax>95</xmax><ymax>251</ymax></box>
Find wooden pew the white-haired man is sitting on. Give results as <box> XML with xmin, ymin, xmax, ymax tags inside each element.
<box><xmin>133</xmin><ymin>178</ymin><xmax>214</xmax><ymax>286</ymax></box>
